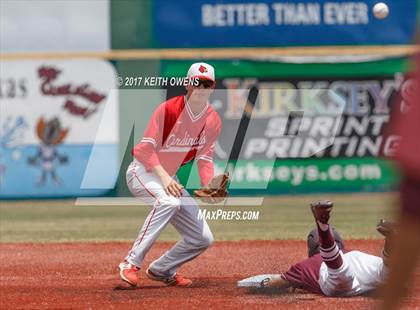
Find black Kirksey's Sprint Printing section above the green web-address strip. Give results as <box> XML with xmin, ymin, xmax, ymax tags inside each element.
<box><xmin>217</xmin><ymin>74</ymin><xmax>406</xmax><ymax>160</ymax></box>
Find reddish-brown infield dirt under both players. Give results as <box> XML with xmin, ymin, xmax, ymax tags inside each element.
<box><xmin>0</xmin><ymin>240</ymin><xmax>420</xmax><ymax>309</ymax></box>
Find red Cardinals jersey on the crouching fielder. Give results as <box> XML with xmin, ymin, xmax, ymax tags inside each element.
<box><xmin>132</xmin><ymin>96</ymin><xmax>222</xmax><ymax>185</ymax></box>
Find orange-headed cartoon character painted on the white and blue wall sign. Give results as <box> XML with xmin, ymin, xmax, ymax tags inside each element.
<box><xmin>28</xmin><ymin>117</ymin><xmax>69</xmax><ymax>185</ymax></box>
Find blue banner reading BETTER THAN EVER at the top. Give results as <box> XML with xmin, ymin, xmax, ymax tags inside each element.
<box><xmin>153</xmin><ymin>0</ymin><xmax>417</xmax><ymax>47</ymax></box>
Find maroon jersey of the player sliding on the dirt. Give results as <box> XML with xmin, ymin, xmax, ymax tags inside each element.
<box><xmin>282</xmin><ymin>254</ymin><xmax>323</xmax><ymax>294</ymax></box>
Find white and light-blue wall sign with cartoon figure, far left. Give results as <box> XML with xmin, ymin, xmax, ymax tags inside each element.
<box><xmin>0</xmin><ymin>60</ymin><xmax>119</xmax><ymax>198</ymax></box>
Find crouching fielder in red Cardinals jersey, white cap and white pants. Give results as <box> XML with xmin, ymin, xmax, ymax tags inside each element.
<box><xmin>119</xmin><ymin>63</ymin><xmax>221</xmax><ymax>287</ymax></box>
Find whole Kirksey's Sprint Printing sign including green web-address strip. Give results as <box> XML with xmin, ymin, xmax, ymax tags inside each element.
<box><xmin>170</xmin><ymin>73</ymin><xmax>413</xmax><ymax>193</ymax></box>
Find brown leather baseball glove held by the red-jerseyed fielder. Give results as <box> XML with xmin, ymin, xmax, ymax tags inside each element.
<box><xmin>194</xmin><ymin>173</ymin><xmax>229</xmax><ymax>203</ymax></box>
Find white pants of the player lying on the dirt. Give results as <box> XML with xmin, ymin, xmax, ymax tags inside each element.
<box><xmin>318</xmin><ymin>251</ymin><xmax>387</xmax><ymax>296</ymax></box>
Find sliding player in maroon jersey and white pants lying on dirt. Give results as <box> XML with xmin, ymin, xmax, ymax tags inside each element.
<box><xmin>238</xmin><ymin>200</ymin><xmax>393</xmax><ymax>297</ymax></box>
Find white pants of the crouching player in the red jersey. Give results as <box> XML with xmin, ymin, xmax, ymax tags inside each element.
<box><xmin>126</xmin><ymin>159</ymin><xmax>213</xmax><ymax>276</ymax></box>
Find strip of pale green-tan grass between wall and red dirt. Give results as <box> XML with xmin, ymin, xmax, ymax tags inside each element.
<box><xmin>0</xmin><ymin>193</ymin><xmax>396</xmax><ymax>242</ymax></box>
